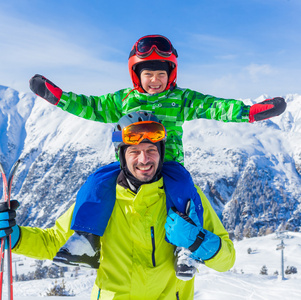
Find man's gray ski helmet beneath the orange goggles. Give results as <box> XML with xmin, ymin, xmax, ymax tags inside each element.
<box><xmin>113</xmin><ymin>111</ymin><xmax>165</xmax><ymax>167</ymax></box>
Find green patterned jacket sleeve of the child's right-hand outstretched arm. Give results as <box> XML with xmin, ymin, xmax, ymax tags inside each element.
<box><xmin>183</xmin><ymin>89</ymin><xmax>250</xmax><ymax>122</ymax></box>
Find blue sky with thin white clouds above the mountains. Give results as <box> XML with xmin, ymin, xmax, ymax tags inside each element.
<box><xmin>0</xmin><ymin>0</ymin><xmax>301</xmax><ymax>99</ymax></box>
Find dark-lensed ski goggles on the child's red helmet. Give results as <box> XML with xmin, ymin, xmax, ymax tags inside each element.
<box><xmin>129</xmin><ymin>35</ymin><xmax>178</xmax><ymax>58</ymax></box>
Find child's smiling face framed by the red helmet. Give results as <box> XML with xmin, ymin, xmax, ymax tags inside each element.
<box><xmin>140</xmin><ymin>70</ymin><xmax>168</xmax><ymax>94</ymax></box>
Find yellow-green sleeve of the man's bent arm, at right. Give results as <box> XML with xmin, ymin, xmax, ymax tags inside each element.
<box><xmin>197</xmin><ymin>187</ymin><xmax>235</xmax><ymax>272</ymax></box>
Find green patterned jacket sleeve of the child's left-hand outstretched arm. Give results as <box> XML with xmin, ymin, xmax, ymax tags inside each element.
<box><xmin>57</xmin><ymin>89</ymin><xmax>129</xmax><ymax>123</ymax></box>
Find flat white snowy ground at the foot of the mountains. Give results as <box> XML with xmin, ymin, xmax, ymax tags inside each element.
<box><xmin>3</xmin><ymin>232</ymin><xmax>301</xmax><ymax>300</ymax></box>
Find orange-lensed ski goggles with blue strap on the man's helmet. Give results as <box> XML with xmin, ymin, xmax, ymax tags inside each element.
<box><xmin>112</xmin><ymin>121</ymin><xmax>166</xmax><ymax>145</ymax></box>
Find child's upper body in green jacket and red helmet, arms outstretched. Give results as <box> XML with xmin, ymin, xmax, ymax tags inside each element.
<box><xmin>30</xmin><ymin>35</ymin><xmax>286</xmax><ymax>266</ymax></box>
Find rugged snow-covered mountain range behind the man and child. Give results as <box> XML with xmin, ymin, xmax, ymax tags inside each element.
<box><xmin>0</xmin><ymin>86</ymin><xmax>301</xmax><ymax>234</ymax></box>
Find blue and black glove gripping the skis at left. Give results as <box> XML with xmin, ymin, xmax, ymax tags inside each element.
<box><xmin>0</xmin><ymin>200</ymin><xmax>20</xmax><ymax>249</ymax></box>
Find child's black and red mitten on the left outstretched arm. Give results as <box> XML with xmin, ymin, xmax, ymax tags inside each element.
<box><xmin>29</xmin><ymin>74</ymin><xmax>63</xmax><ymax>105</ymax></box>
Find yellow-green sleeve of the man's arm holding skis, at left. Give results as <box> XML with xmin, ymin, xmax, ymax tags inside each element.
<box><xmin>12</xmin><ymin>205</ymin><xmax>74</xmax><ymax>260</ymax></box>
